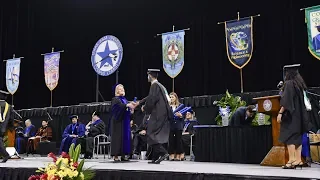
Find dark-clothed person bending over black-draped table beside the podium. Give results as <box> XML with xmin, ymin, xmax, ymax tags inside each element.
<box><xmin>230</xmin><ymin>105</ymin><xmax>256</xmax><ymax>126</ymax></box>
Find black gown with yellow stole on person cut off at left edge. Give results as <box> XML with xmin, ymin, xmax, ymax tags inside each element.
<box><xmin>0</xmin><ymin>101</ymin><xmax>13</xmax><ymax>157</ymax></box>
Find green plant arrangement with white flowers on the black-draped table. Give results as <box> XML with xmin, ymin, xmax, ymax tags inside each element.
<box><xmin>215</xmin><ymin>90</ymin><xmax>246</xmax><ymax>125</ymax></box>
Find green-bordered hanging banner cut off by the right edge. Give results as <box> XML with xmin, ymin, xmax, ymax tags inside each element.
<box><xmin>305</xmin><ymin>6</ymin><xmax>320</xmax><ymax>60</ymax></box>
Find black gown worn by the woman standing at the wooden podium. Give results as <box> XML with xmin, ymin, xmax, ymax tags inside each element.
<box><xmin>279</xmin><ymin>80</ymin><xmax>312</xmax><ymax>145</ymax></box>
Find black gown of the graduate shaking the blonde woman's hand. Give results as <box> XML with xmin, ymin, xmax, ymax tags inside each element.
<box><xmin>144</xmin><ymin>82</ymin><xmax>173</xmax><ymax>145</ymax></box>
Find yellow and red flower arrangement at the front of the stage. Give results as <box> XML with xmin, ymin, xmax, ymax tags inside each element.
<box><xmin>28</xmin><ymin>144</ymin><xmax>94</xmax><ymax>180</ymax></box>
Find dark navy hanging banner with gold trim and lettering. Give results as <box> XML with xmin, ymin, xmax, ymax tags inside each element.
<box><xmin>225</xmin><ymin>17</ymin><xmax>253</xmax><ymax>69</ymax></box>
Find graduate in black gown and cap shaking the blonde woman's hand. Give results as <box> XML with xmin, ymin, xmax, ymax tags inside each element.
<box><xmin>143</xmin><ymin>69</ymin><xmax>173</xmax><ymax>164</ymax></box>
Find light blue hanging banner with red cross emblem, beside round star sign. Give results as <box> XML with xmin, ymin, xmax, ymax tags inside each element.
<box><xmin>162</xmin><ymin>30</ymin><xmax>185</xmax><ymax>78</ymax></box>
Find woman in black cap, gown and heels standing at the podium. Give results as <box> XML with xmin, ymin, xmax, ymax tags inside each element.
<box><xmin>277</xmin><ymin>65</ymin><xmax>312</xmax><ymax>169</ymax></box>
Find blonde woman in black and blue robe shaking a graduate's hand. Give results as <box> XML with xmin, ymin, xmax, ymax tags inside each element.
<box><xmin>110</xmin><ymin>84</ymin><xmax>136</xmax><ymax>162</ymax></box>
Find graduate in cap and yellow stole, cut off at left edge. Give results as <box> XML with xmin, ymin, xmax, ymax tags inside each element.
<box><xmin>0</xmin><ymin>91</ymin><xmax>13</xmax><ymax>163</ymax></box>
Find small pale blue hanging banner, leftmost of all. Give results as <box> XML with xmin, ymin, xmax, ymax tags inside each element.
<box><xmin>6</xmin><ymin>58</ymin><xmax>21</xmax><ymax>95</ymax></box>
